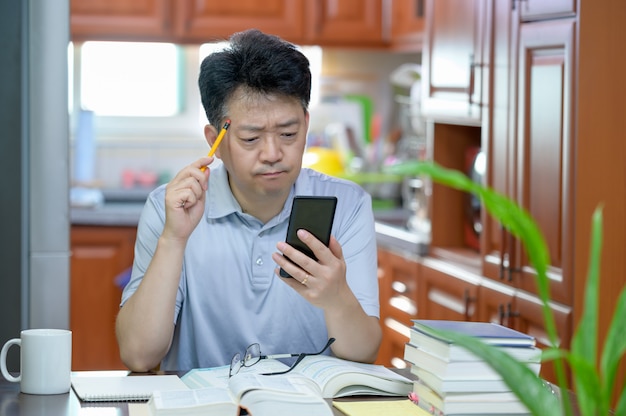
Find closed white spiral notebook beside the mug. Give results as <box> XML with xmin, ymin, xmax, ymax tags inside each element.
<box><xmin>72</xmin><ymin>373</ymin><xmax>188</xmax><ymax>402</ymax></box>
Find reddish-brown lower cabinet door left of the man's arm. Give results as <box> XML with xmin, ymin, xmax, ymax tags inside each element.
<box><xmin>70</xmin><ymin>225</ymin><xmax>136</xmax><ymax>371</ymax></box>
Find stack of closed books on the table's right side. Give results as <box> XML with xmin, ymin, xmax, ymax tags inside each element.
<box><xmin>404</xmin><ymin>320</ymin><xmax>541</xmax><ymax>416</ymax></box>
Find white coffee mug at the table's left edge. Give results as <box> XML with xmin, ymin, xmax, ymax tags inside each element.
<box><xmin>0</xmin><ymin>329</ymin><xmax>72</xmax><ymax>394</ymax></box>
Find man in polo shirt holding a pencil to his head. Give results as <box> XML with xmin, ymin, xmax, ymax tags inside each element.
<box><xmin>116</xmin><ymin>30</ymin><xmax>381</xmax><ymax>371</ymax></box>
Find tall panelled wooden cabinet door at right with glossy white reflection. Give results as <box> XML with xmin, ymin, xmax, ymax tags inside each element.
<box><xmin>514</xmin><ymin>19</ymin><xmax>575</xmax><ymax>305</ymax></box>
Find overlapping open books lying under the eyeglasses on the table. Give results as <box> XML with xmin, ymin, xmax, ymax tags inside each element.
<box><xmin>148</xmin><ymin>356</ymin><xmax>413</xmax><ymax>416</ymax></box>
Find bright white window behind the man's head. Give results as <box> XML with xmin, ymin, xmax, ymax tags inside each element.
<box><xmin>69</xmin><ymin>41</ymin><xmax>322</xmax><ymax>140</ymax></box>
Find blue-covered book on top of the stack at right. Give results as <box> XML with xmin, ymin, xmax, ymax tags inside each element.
<box><xmin>413</xmin><ymin>319</ymin><xmax>535</xmax><ymax>347</ymax></box>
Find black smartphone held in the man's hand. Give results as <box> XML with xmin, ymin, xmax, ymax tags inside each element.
<box><xmin>280</xmin><ymin>196</ymin><xmax>337</xmax><ymax>277</ymax></box>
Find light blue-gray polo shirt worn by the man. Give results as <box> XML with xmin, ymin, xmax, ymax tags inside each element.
<box><xmin>121</xmin><ymin>165</ymin><xmax>379</xmax><ymax>370</ymax></box>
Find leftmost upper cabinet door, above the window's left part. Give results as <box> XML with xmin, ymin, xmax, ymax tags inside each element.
<box><xmin>70</xmin><ymin>0</ymin><xmax>172</xmax><ymax>41</ymax></box>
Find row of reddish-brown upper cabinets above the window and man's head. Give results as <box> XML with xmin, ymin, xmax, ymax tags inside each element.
<box><xmin>70</xmin><ymin>0</ymin><xmax>425</xmax><ymax>51</ymax></box>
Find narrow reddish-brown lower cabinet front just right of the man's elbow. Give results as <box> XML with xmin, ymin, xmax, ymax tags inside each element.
<box><xmin>376</xmin><ymin>250</ymin><xmax>419</xmax><ymax>367</ymax></box>
